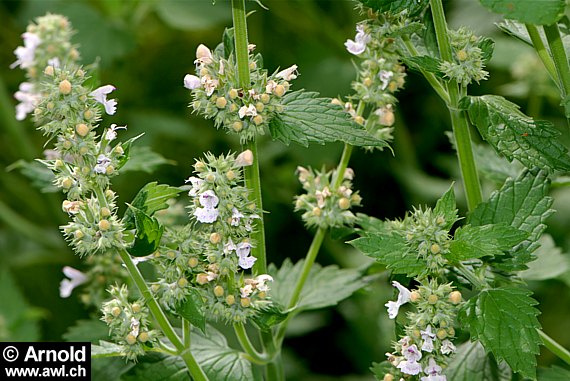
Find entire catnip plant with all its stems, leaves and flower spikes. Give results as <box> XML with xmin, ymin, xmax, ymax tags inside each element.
<box><xmin>7</xmin><ymin>0</ymin><xmax>570</xmax><ymax>381</ymax></box>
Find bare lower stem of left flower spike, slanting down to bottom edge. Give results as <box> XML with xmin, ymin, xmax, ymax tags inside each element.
<box><xmin>118</xmin><ymin>249</ymin><xmax>208</xmax><ymax>381</ymax></box>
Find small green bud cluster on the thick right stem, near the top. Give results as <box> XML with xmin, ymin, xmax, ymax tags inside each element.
<box><xmin>440</xmin><ymin>28</ymin><xmax>489</xmax><ymax>86</ymax></box>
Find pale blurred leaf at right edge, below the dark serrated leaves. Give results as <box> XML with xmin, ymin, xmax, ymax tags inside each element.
<box><xmin>520</xmin><ymin>234</ymin><xmax>570</xmax><ymax>281</ymax></box>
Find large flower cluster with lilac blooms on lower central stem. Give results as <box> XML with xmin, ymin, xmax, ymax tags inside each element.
<box><xmin>152</xmin><ymin>150</ymin><xmax>273</xmax><ymax>323</ymax></box>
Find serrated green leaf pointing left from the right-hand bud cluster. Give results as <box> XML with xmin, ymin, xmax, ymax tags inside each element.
<box><xmin>348</xmin><ymin>232</ymin><xmax>427</xmax><ymax>277</ymax></box>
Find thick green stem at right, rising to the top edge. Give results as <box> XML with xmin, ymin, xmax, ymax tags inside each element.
<box><xmin>430</xmin><ymin>0</ymin><xmax>483</xmax><ymax>211</ymax></box>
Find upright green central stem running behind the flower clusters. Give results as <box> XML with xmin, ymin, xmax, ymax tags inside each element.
<box><xmin>232</xmin><ymin>0</ymin><xmax>267</xmax><ymax>274</ymax></box>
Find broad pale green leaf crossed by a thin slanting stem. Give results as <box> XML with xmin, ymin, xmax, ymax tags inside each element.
<box><xmin>268</xmin><ymin>259</ymin><xmax>367</xmax><ymax>311</ymax></box>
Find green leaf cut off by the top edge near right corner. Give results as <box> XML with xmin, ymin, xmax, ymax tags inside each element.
<box><xmin>480</xmin><ymin>0</ymin><xmax>566</xmax><ymax>25</ymax></box>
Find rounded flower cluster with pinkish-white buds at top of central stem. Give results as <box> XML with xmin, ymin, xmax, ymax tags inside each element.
<box><xmin>184</xmin><ymin>45</ymin><xmax>298</xmax><ymax>143</ymax></box>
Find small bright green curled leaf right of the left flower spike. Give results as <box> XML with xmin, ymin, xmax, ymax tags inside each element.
<box><xmin>123</xmin><ymin>182</ymin><xmax>182</xmax><ymax>229</ymax></box>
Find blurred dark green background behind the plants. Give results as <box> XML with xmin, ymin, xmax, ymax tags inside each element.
<box><xmin>0</xmin><ymin>0</ymin><xmax>570</xmax><ymax>380</ymax></box>
